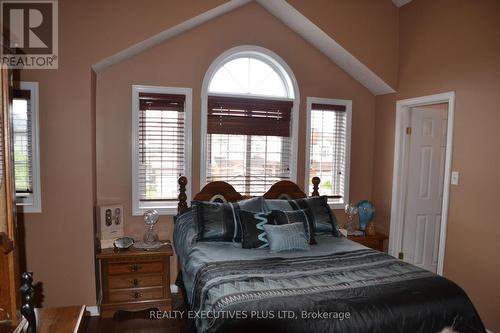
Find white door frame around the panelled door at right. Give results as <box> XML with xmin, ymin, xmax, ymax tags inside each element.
<box><xmin>389</xmin><ymin>91</ymin><xmax>455</xmax><ymax>275</ymax></box>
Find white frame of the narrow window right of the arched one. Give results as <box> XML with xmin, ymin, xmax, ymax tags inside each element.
<box><xmin>304</xmin><ymin>97</ymin><xmax>352</xmax><ymax>209</ymax></box>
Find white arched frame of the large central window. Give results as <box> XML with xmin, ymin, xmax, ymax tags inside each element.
<box><xmin>200</xmin><ymin>45</ymin><xmax>300</xmax><ymax>189</ymax></box>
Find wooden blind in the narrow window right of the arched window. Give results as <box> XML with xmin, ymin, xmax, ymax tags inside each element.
<box><xmin>309</xmin><ymin>103</ymin><xmax>347</xmax><ymax>200</ymax></box>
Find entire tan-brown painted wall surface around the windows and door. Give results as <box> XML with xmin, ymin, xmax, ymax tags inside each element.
<box><xmin>14</xmin><ymin>0</ymin><xmax>500</xmax><ymax>331</ymax></box>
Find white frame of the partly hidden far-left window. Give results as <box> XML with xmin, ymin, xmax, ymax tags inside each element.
<box><xmin>16</xmin><ymin>81</ymin><xmax>42</xmax><ymax>213</ymax></box>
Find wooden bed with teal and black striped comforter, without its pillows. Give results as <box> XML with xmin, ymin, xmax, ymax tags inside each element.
<box><xmin>174</xmin><ymin>177</ymin><xmax>486</xmax><ymax>333</ymax></box>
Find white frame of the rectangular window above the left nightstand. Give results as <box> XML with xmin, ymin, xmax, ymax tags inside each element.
<box><xmin>132</xmin><ymin>84</ymin><xmax>193</xmax><ymax>216</ymax></box>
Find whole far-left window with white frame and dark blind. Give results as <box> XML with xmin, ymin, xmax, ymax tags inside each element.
<box><xmin>12</xmin><ymin>82</ymin><xmax>42</xmax><ymax>213</ymax></box>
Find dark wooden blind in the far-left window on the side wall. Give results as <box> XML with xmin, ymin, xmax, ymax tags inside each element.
<box><xmin>12</xmin><ymin>89</ymin><xmax>33</xmax><ymax>195</ymax></box>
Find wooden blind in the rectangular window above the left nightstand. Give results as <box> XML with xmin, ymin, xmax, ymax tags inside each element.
<box><xmin>137</xmin><ymin>93</ymin><xmax>185</xmax><ymax>202</ymax></box>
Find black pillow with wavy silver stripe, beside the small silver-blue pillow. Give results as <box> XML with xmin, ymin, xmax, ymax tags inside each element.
<box><xmin>238</xmin><ymin>210</ymin><xmax>273</xmax><ymax>249</ymax></box>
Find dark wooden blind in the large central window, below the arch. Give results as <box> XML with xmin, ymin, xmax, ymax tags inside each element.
<box><xmin>206</xmin><ymin>96</ymin><xmax>293</xmax><ymax>195</ymax></box>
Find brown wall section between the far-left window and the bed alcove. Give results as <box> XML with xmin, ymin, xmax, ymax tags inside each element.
<box><xmin>20</xmin><ymin>0</ymin><xmax>234</xmax><ymax>306</ymax></box>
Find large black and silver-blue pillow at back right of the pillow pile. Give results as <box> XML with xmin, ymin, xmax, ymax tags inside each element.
<box><xmin>265</xmin><ymin>196</ymin><xmax>340</xmax><ymax>237</ymax></box>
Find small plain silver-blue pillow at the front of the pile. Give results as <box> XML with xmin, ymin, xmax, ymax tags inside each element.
<box><xmin>264</xmin><ymin>222</ymin><xmax>310</xmax><ymax>252</ymax></box>
